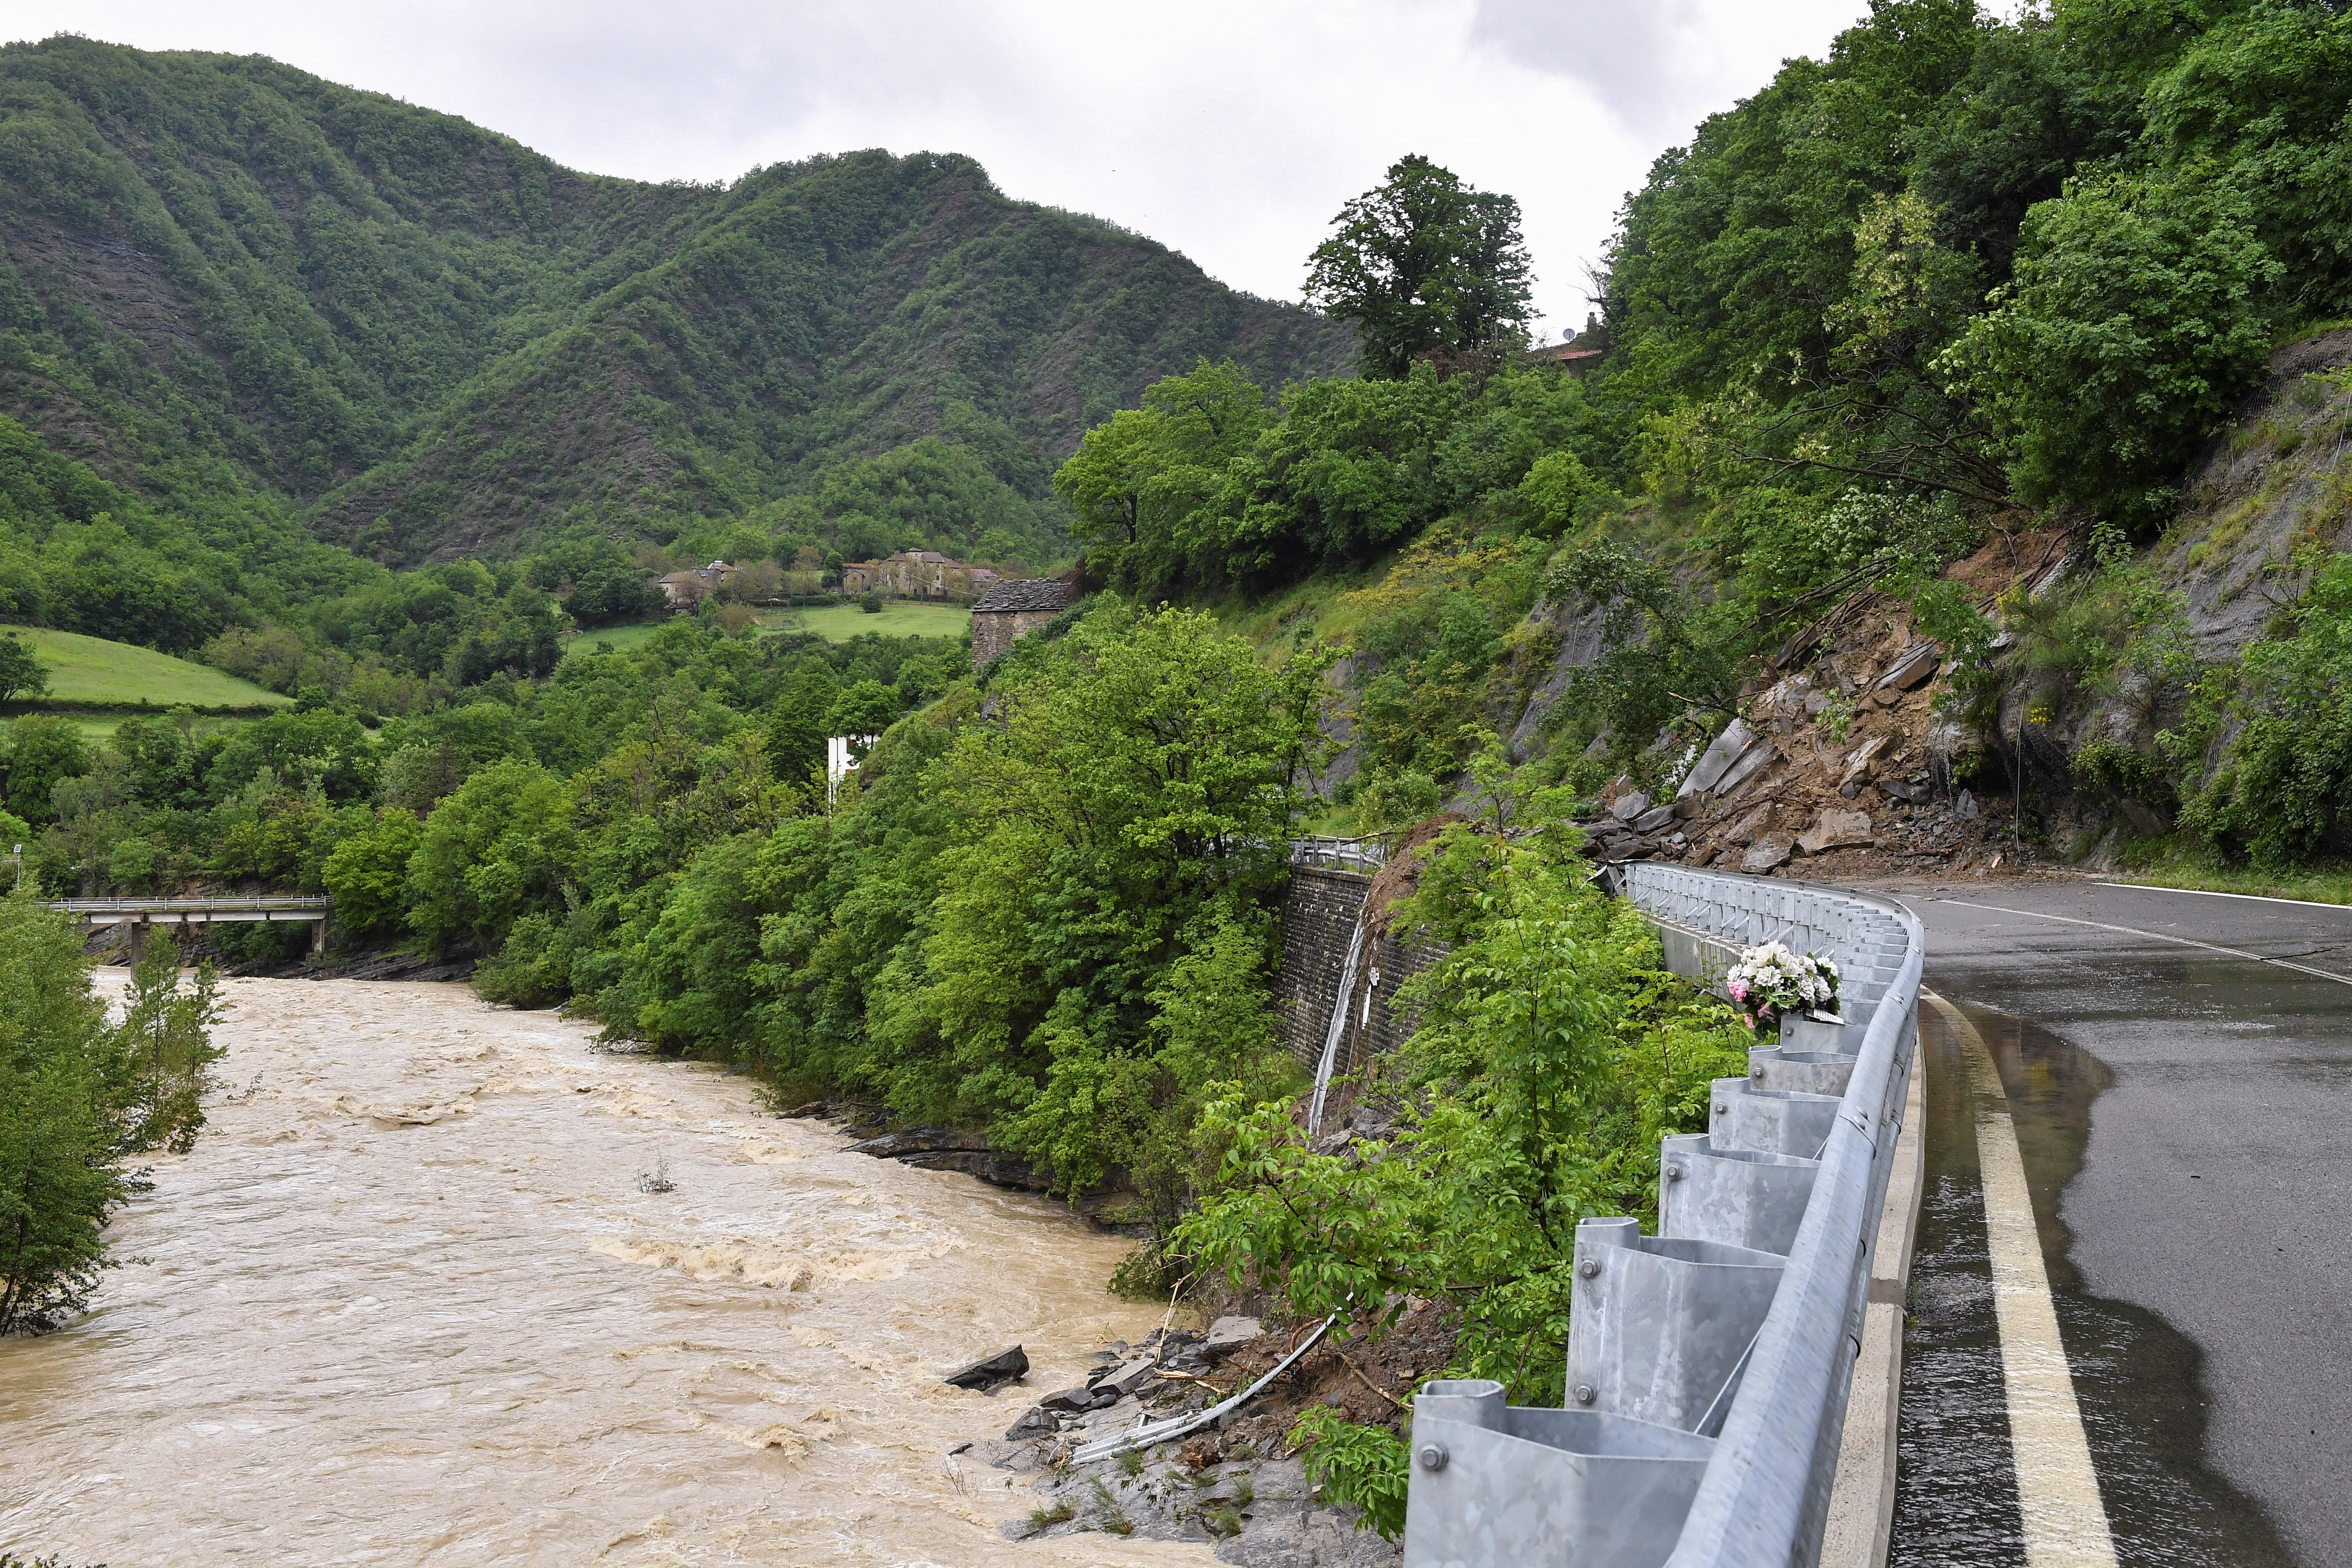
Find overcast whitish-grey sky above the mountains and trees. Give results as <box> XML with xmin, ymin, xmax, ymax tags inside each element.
<box><xmin>0</xmin><ymin>0</ymin><xmax>1865</xmax><ymax>339</ymax></box>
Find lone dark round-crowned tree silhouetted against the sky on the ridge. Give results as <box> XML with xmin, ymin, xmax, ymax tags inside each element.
<box><xmin>1306</xmin><ymin>153</ymin><xmax>1534</xmax><ymax>378</ymax></box>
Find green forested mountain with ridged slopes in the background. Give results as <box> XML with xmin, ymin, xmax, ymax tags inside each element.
<box><xmin>0</xmin><ymin>38</ymin><xmax>1355</xmax><ymax>564</ymax></box>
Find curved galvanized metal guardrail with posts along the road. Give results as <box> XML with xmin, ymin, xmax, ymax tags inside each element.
<box><xmin>1404</xmin><ymin>863</ymin><xmax>1924</xmax><ymax>1568</ymax></box>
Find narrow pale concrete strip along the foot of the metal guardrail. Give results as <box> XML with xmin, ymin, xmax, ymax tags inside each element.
<box><xmin>1818</xmin><ymin>990</ymin><xmax>1947</xmax><ymax>1568</ymax></box>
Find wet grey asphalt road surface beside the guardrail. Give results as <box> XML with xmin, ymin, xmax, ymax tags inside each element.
<box><xmin>1886</xmin><ymin>879</ymin><xmax>2352</xmax><ymax>1568</ymax></box>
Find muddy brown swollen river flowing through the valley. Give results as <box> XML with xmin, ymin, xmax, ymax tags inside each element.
<box><xmin>0</xmin><ymin>971</ymin><xmax>1214</xmax><ymax>1568</ymax></box>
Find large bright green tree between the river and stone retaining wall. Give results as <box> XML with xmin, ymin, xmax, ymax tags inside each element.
<box><xmin>870</xmin><ymin>606</ymin><xmax>1327</xmax><ymax>1218</ymax></box>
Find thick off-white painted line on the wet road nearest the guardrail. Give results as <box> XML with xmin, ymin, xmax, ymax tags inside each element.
<box><xmin>1943</xmin><ymin>1006</ymin><xmax>2114</xmax><ymax>1568</ymax></box>
